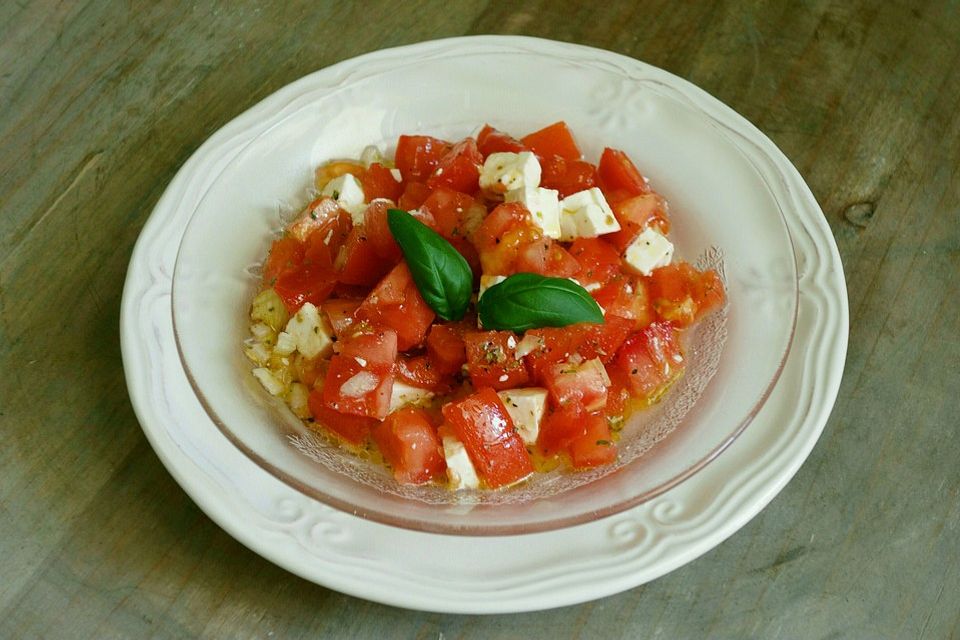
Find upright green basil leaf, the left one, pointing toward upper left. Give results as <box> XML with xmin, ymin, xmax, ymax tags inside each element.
<box><xmin>387</xmin><ymin>209</ymin><xmax>473</xmax><ymax>320</ymax></box>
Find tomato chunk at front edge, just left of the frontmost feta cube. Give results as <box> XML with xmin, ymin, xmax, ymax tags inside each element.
<box><xmin>371</xmin><ymin>407</ymin><xmax>447</xmax><ymax>484</ymax></box>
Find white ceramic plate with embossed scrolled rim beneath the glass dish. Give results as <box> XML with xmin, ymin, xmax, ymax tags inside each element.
<box><xmin>121</xmin><ymin>37</ymin><xmax>847</xmax><ymax>613</ymax></box>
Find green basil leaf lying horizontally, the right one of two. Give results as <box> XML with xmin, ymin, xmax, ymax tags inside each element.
<box><xmin>477</xmin><ymin>273</ymin><xmax>603</xmax><ymax>333</ymax></box>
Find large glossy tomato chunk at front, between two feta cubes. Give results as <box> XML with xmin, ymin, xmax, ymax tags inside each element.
<box><xmin>443</xmin><ymin>387</ymin><xmax>533</xmax><ymax>489</ymax></box>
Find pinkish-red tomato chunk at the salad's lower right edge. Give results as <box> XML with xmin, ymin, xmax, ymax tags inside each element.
<box><xmin>613</xmin><ymin>322</ymin><xmax>684</xmax><ymax>399</ymax></box>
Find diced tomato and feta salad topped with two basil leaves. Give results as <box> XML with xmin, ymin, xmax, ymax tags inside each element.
<box><xmin>246</xmin><ymin>122</ymin><xmax>725</xmax><ymax>489</ymax></box>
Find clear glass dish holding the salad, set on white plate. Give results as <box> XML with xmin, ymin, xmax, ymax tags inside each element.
<box><xmin>172</xmin><ymin>41</ymin><xmax>798</xmax><ymax>535</ymax></box>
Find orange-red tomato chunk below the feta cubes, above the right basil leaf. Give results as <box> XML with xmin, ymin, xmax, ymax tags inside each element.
<box><xmin>473</xmin><ymin>202</ymin><xmax>543</xmax><ymax>275</ymax></box>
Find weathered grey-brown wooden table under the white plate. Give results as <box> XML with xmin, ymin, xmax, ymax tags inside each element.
<box><xmin>0</xmin><ymin>0</ymin><xmax>960</xmax><ymax>639</ymax></box>
